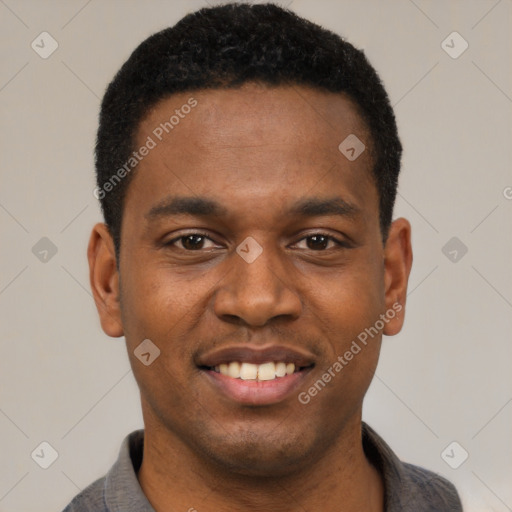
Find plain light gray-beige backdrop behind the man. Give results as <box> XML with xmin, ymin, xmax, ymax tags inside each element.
<box><xmin>0</xmin><ymin>0</ymin><xmax>512</xmax><ymax>512</ymax></box>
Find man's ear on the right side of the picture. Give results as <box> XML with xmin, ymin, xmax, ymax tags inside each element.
<box><xmin>383</xmin><ymin>218</ymin><xmax>412</xmax><ymax>336</ymax></box>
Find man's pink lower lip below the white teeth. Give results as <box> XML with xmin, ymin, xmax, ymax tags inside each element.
<box><xmin>203</xmin><ymin>368</ymin><xmax>311</xmax><ymax>405</ymax></box>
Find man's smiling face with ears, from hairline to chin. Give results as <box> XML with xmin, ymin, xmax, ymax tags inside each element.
<box><xmin>89</xmin><ymin>84</ymin><xmax>410</xmax><ymax>475</ymax></box>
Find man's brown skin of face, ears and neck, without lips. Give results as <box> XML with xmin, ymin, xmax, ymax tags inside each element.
<box><xmin>88</xmin><ymin>84</ymin><xmax>412</xmax><ymax>512</ymax></box>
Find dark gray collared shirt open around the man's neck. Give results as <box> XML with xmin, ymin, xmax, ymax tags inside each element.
<box><xmin>63</xmin><ymin>423</ymin><xmax>462</xmax><ymax>512</ymax></box>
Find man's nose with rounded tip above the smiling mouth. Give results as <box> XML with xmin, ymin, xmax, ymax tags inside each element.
<box><xmin>214</xmin><ymin>245</ymin><xmax>302</xmax><ymax>327</ymax></box>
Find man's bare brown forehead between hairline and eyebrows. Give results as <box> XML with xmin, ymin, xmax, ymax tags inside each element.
<box><xmin>127</xmin><ymin>83</ymin><xmax>373</xmax><ymax>220</ymax></box>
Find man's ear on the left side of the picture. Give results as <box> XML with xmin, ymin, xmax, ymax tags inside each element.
<box><xmin>87</xmin><ymin>223</ymin><xmax>124</xmax><ymax>338</ymax></box>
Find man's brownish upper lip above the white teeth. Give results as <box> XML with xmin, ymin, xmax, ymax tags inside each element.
<box><xmin>197</xmin><ymin>344</ymin><xmax>314</xmax><ymax>368</ymax></box>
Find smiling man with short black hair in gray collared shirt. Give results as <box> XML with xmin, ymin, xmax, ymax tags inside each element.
<box><xmin>62</xmin><ymin>4</ymin><xmax>461</xmax><ymax>512</ymax></box>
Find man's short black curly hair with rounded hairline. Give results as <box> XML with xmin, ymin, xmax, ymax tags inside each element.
<box><xmin>95</xmin><ymin>3</ymin><xmax>402</xmax><ymax>261</ymax></box>
